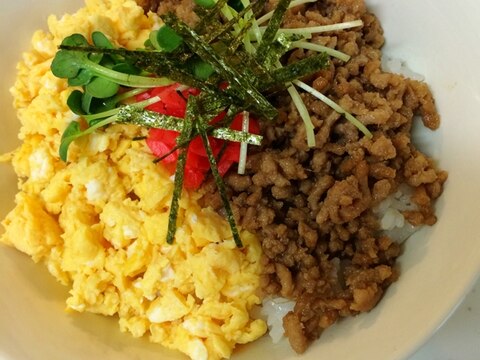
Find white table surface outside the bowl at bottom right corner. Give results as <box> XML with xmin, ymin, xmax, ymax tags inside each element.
<box><xmin>408</xmin><ymin>281</ymin><xmax>480</xmax><ymax>360</ymax></box>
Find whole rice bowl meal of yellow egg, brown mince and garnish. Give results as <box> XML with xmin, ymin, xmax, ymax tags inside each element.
<box><xmin>0</xmin><ymin>0</ymin><xmax>447</xmax><ymax>360</ymax></box>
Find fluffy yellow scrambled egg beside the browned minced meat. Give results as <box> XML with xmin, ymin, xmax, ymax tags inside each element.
<box><xmin>1</xmin><ymin>0</ymin><xmax>267</xmax><ymax>359</ymax></box>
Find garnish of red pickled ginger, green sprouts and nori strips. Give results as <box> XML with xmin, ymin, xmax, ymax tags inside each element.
<box><xmin>51</xmin><ymin>0</ymin><xmax>372</xmax><ymax>247</ymax></box>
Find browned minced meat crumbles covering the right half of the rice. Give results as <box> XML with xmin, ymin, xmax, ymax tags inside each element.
<box><xmin>142</xmin><ymin>0</ymin><xmax>447</xmax><ymax>353</ymax></box>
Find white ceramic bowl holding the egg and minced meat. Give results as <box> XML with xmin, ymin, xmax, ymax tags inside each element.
<box><xmin>0</xmin><ymin>0</ymin><xmax>480</xmax><ymax>360</ymax></box>
